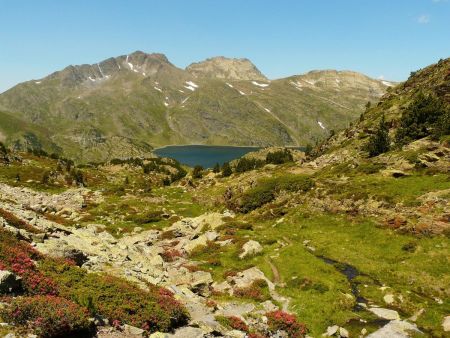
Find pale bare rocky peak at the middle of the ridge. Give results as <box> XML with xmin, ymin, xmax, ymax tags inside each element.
<box><xmin>186</xmin><ymin>56</ymin><xmax>267</xmax><ymax>81</ymax></box>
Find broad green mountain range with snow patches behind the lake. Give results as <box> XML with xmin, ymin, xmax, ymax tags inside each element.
<box><xmin>0</xmin><ymin>52</ymin><xmax>390</xmax><ymax>161</ymax></box>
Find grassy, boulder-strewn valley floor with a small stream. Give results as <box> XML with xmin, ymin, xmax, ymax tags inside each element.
<box><xmin>0</xmin><ymin>147</ymin><xmax>450</xmax><ymax>337</ymax></box>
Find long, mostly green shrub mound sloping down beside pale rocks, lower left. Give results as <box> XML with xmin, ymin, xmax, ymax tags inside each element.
<box><xmin>36</xmin><ymin>261</ymin><xmax>189</xmax><ymax>332</ymax></box>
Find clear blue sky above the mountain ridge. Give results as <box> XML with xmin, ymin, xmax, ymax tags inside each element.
<box><xmin>0</xmin><ymin>0</ymin><xmax>450</xmax><ymax>92</ymax></box>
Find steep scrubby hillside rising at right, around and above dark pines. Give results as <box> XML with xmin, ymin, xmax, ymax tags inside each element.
<box><xmin>310</xmin><ymin>58</ymin><xmax>450</xmax><ymax>165</ymax></box>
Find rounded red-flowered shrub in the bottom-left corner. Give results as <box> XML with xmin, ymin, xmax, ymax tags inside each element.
<box><xmin>0</xmin><ymin>296</ymin><xmax>94</xmax><ymax>337</ymax></box>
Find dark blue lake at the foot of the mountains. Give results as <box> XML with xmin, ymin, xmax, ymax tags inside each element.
<box><xmin>153</xmin><ymin>145</ymin><xmax>261</xmax><ymax>168</ymax></box>
